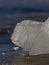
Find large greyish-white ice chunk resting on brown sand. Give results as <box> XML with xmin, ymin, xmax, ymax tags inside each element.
<box><xmin>11</xmin><ymin>18</ymin><xmax>49</xmax><ymax>55</ymax></box>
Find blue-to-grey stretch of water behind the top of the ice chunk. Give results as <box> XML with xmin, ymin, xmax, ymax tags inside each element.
<box><xmin>0</xmin><ymin>7</ymin><xmax>49</xmax><ymax>25</ymax></box>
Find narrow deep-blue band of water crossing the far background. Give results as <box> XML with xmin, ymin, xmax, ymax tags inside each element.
<box><xmin>0</xmin><ymin>7</ymin><xmax>49</xmax><ymax>14</ymax></box>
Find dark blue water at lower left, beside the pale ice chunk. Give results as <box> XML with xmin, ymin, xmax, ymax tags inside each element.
<box><xmin>0</xmin><ymin>33</ymin><xmax>22</xmax><ymax>60</ymax></box>
